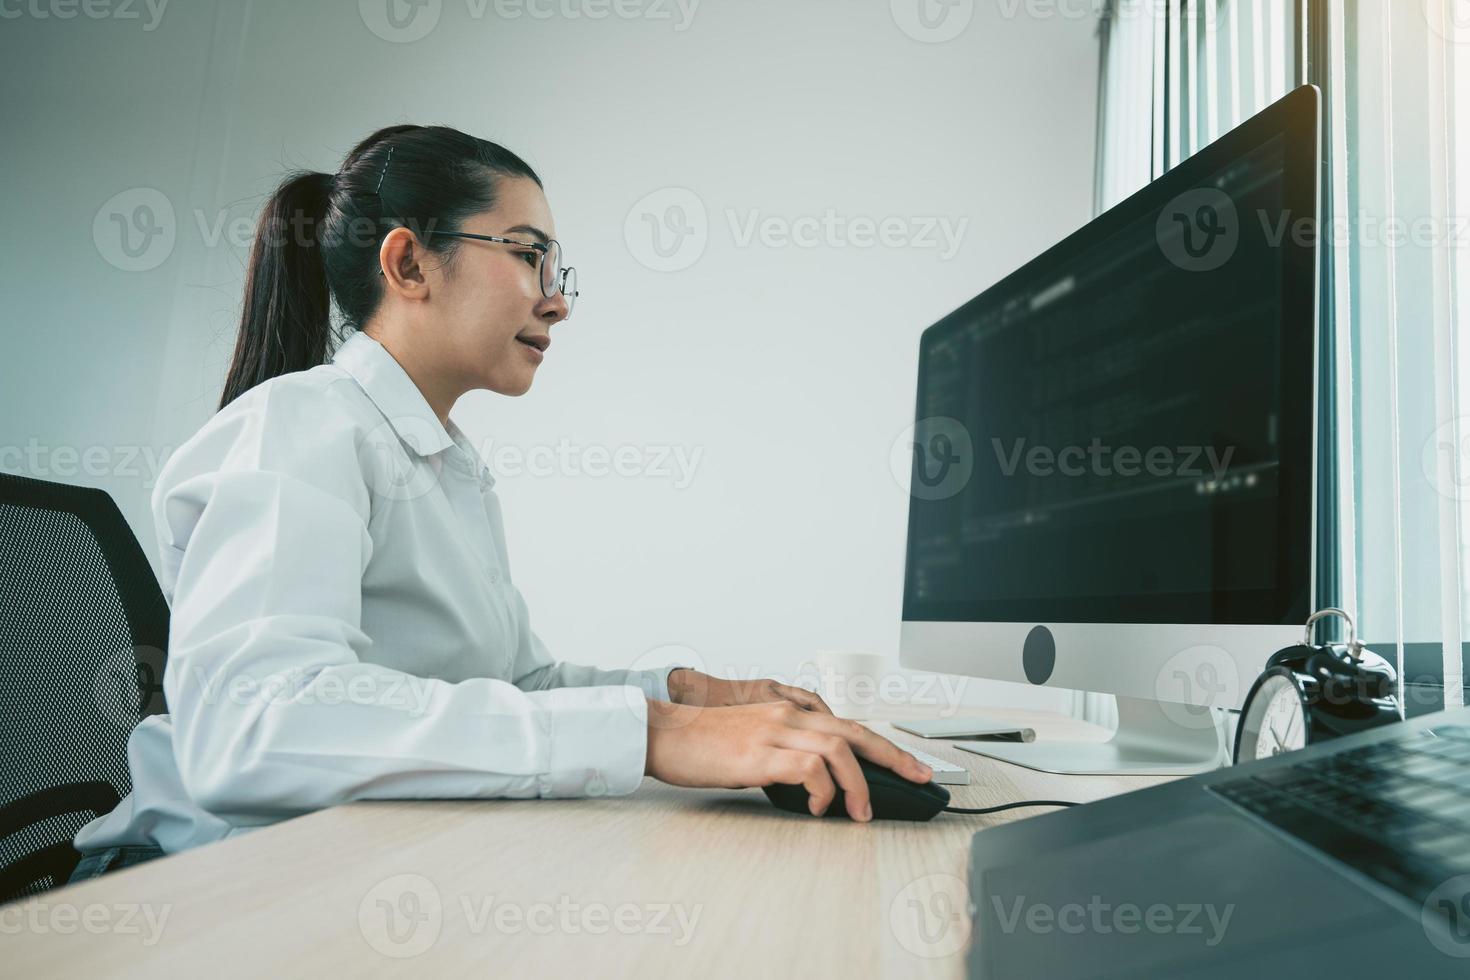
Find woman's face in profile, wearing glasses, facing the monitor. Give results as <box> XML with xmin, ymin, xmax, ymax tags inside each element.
<box><xmin>423</xmin><ymin>176</ymin><xmax>567</xmax><ymax>395</ymax></box>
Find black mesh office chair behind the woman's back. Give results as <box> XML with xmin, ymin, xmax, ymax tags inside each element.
<box><xmin>0</xmin><ymin>473</ymin><xmax>169</xmax><ymax>902</ymax></box>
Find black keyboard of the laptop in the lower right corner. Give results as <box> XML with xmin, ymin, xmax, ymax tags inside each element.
<box><xmin>1208</xmin><ymin>726</ymin><xmax>1470</xmax><ymax>902</ymax></box>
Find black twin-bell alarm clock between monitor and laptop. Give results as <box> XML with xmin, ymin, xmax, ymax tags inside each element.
<box><xmin>1235</xmin><ymin>608</ymin><xmax>1402</xmax><ymax>764</ymax></box>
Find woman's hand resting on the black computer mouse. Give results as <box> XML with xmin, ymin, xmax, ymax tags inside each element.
<box><xmin>644</xmin><ymin>701</ymin><xmax>932</xmax><ymax>821</ymax></box>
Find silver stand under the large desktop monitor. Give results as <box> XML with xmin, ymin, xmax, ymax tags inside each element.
<box><xmin>956</xmin><ymin>696</ymin><xmax>1227</xmax><ymax>776</ymax></box>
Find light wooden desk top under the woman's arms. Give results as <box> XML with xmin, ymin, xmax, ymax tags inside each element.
<box><xmin>0</xmin><ymin>713</ymin><xmax>1163</xmax><ymax>980</ymax></box>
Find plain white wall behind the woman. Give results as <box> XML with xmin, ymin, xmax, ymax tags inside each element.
<box><xmin>0</xmin><ymin>0</ymin><xmax>1097</xmax><ymax>719</ymax></box>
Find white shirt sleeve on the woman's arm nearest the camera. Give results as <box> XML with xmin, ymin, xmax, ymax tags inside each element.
<box><xmin>154</xmin><ymin>382</ymin><xmax>647</xmax><ymax>824</ymax></box>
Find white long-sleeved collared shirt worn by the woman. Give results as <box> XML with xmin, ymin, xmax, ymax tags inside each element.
<box><xmin>76</xmin><ymin>332</ymin><xmax>673</xmax><ymax>854</ymax></box>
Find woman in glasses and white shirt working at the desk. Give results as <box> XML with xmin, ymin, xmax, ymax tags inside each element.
<box><xmin>74</xmin><ymin>126</ymin><xmax>929</xmax><ymax>880</ymax></box>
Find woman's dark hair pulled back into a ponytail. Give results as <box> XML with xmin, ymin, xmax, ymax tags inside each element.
<box><xmin>219</xmin><ymin>126</ymin><xmax>541</xmax><ymax>408</ymax></box>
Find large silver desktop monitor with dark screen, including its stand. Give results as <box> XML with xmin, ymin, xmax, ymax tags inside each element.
<box><xmin>900</xmin><ymin>87</ymin><xmax>1320</xmax><ymax>774</ymax></box>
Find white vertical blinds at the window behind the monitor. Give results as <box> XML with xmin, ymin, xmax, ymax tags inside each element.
<box><xmin>1083</xmin><ymin>0</ymin><xmax>1470</xmax><ymax>718</ymax></box>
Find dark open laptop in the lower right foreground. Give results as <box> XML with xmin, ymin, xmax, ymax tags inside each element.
<box><xmin>966</xmin><ymin>708</ymin><xmax>1470</xmax><ymax>980</ymax></box>
